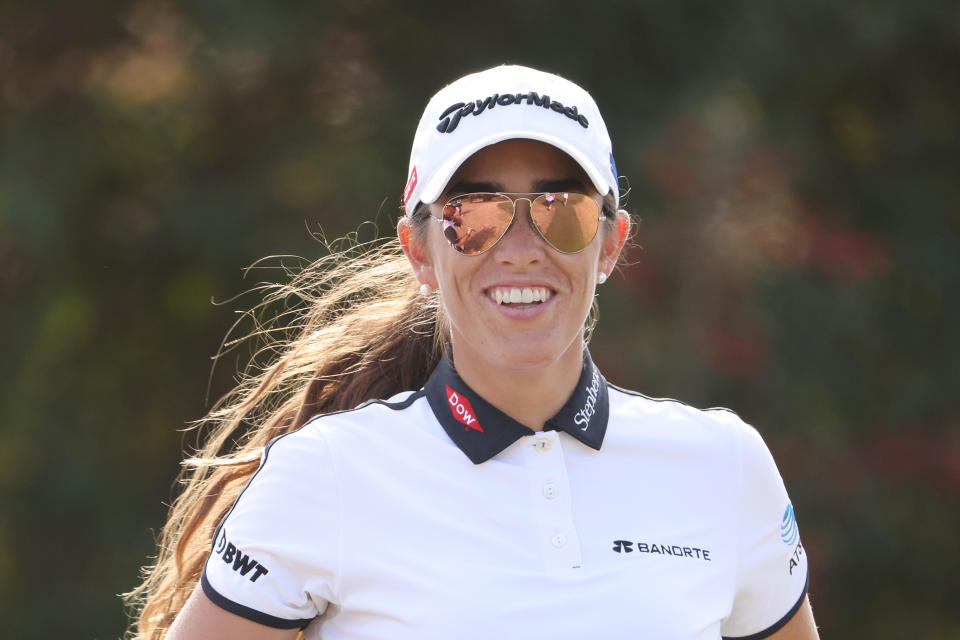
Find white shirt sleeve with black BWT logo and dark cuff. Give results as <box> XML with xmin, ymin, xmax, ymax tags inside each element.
<box><xmin>201</xmin><ymin>425</ymin><xmax>340</xmax><ymax>629</ymax></box>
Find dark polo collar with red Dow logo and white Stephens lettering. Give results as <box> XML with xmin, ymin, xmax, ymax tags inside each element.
<box><xmin>424</xmin><ymin>348</ymin><xmax>610</xmax><ymax>464</ymax></box>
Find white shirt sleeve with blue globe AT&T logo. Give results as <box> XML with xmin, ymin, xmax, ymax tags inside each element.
<box><xmin>720</xmin><ymin>423</ymin><xmax>807</xmax><ymax>640</ymax></box>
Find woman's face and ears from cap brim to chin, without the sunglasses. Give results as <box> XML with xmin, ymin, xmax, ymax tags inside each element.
<box><xmin>402</xmin><ymin>140</ymin><xmax>626</xmax><ymax>371</ymax></box>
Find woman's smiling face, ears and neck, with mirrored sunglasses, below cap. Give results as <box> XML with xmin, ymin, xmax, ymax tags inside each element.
<box><xmin>398</xmin><ymin>139</ymin><xmax>629</xmax><ymax>420</ymax></box>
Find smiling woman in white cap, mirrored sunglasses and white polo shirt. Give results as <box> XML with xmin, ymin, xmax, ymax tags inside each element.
<box><xmin>125</xmin><ymin>66</ymin><xmax>817</xmax><ymax>640</ymax></box>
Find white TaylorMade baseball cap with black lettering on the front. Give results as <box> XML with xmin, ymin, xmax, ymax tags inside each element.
<box><xmin>403</xmin><ymin>65</ymin><xmax>620</xmax><ymax>215</ymax></box>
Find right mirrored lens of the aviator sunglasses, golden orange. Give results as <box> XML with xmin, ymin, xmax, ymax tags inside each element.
<box><xmin>530</xmin><ymin>193</ymin><xmax>600</xmax><ymax>253</ymax></box>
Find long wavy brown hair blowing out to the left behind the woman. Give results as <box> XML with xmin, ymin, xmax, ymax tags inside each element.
<box><xmin>124</xmin><ymin>197</ymin><xmax>614</xmax><ymax>640</ymax></box>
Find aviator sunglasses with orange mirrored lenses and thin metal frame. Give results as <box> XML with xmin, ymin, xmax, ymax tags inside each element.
<box><xmin>436</xmin><ymin>193</ymin><xmax>606</xmax><ymax>256</ymax></box>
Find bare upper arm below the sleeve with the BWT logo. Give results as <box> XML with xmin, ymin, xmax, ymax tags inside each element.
<box><xmin>167</xmin><ymin>584</ymin><xmax>300</xmax><ymax>640</ymax></box>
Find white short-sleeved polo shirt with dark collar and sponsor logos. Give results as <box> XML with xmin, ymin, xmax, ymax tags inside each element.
<box><xmin>202</xmin><ymin>351</ymin><xmax>807</xmax><ymax>640</ymax></box>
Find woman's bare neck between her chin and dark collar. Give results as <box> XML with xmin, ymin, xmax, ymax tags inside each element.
<box><xmin>444</xmin><ymin>337</ymin><xmax>584</xmax><ymax>431</ymax></box>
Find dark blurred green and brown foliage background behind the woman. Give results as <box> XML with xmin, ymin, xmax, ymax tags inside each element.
<box><xmin>0</xmin><ymin>0</ymin><xmax>960</xmax><ymax>639</ymax></box>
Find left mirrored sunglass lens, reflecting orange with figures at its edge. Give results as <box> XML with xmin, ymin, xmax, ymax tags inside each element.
<box><xmin>443</xmin><ymin>193</ymin><xmax>513</xmax><ymax>255</ymax></box>
